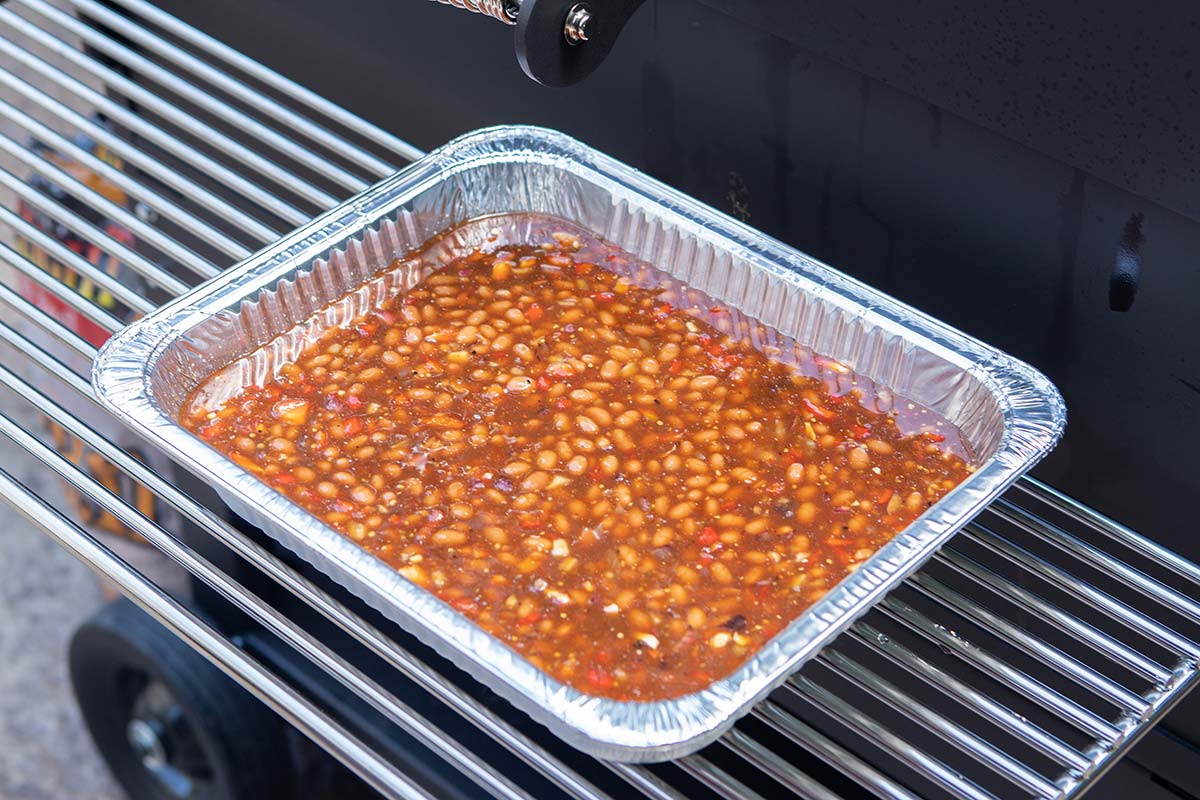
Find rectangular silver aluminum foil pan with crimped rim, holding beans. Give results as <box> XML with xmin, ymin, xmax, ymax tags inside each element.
<box><xmin>94</xmin><ymin>127</ymin><xmax>1066</xmax><ymax>762</ymax></box>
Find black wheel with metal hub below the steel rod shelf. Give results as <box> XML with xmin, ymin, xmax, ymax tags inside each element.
<box><xmin>68</xmin><ymin>600</ymin><xmax>294</xmax><ymax>800</ymax></box>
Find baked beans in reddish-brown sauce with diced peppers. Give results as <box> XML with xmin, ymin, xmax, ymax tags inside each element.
<box><xmin>182</xmin><ymin>221</ymin><xmax>971</xmax><ymax>700</ymax></box>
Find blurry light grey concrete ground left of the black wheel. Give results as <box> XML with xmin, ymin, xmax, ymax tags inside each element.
<box><xmin>0</xmin><ymin>398</ymin><xmax>124</xmax><ymax>800</ymax></box>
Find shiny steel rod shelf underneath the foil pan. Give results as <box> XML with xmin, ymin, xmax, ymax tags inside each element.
<box><xmin>0</xmin><ymin>0</ymin><xmax>1200</xmax><ymax>800</ymax></box>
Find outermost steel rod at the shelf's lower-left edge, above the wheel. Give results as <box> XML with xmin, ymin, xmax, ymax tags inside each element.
<box><xmin>0</xmin><ymin>468</ymin><xmax>434</xmax><ymax>800</ymax></box>
